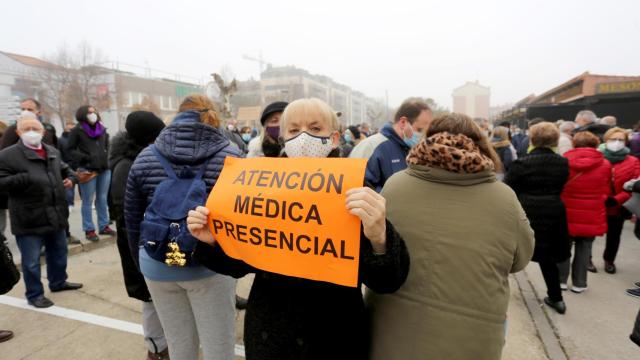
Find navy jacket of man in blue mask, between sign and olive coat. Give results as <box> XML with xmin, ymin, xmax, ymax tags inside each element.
<box><xmin>365</xmin><ymin>123</ymin><xmax>411</xmax><ymax>192</ymax></box>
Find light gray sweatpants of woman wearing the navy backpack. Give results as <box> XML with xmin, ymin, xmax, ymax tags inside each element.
<box><xmin>145</xmin><ymin>274</ymin><xmax>236</xmax><ymax>360</ymax></box>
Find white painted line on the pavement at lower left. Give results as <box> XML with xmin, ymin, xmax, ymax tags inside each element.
<box><xmin>0</xmin><ymin>295</ymin><xmax>244</xmax><ymax>357</ymax></box>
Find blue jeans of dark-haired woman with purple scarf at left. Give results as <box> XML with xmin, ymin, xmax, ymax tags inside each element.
<box><xmin>78</xmin><ymin>170</ymin><xmax>111</xmax><ymax>232</ymax></box>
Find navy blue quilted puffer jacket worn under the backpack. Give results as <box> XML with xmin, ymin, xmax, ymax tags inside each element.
<box><xmin>124</xmin><ymin>111</ymin><xmax>242</xmax><ymax>263</ymax></box>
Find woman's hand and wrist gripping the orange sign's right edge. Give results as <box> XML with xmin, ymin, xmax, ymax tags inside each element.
<box><xmin>347</xmin><ymin>187</ymin><xmax>387</xmax><ymax>254</ymax></box>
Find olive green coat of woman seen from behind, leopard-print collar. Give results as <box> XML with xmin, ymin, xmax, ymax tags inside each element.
<box><xmin>366</xmin><ymin>165</ymin><xmax>534</xmax><ymax>360</ymax></box>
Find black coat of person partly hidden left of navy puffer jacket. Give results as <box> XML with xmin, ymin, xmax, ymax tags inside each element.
<box><xmin>109</xmin><ymin>132</ymin><xmax>151</xmax><ymax>301</ymax></box>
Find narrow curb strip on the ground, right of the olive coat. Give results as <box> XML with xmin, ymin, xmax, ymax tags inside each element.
<box><xmin>514</xmin><ymin>270</ymin><xmax>569</xmax><ymax>360</ymax></box>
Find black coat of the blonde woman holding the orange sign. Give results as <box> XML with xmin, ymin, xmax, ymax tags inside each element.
<box><xmin>194</xmin><ymin>222</ymin><xmax>409</xmax><ymax>360</ymax></box>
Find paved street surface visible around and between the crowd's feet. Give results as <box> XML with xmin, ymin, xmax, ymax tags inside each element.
<box><xmin>0</xmin><ymin>212</ymin><xmax>640</xmax><ymax>360</ymax></box>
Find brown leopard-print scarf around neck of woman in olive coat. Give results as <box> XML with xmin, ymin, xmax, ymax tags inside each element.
<box><xmin>407</xmin><ymin>132</ymin><xmax>495</xmax><ymax>174</ymax></box>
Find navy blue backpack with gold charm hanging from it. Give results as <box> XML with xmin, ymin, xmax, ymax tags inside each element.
<box><xmin>140</xmin><ymin>145</ymin><xmax>208</xmax><ymax>266</ymax></box>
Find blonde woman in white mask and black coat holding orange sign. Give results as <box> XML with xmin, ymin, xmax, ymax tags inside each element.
<box><xmin>187</xmin><ymin>99</ymin><xmax>409</xmax><ymax>360</ymax></box>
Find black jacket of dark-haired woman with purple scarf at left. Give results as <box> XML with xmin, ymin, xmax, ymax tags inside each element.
<box><xmin>67</xmin><ymin>123</ymin><xmax>109</xmax><ymax>172</ymax></box>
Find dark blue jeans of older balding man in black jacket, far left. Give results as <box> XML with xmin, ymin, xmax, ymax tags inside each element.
<box><xmin>16</xmin><ymin>230</ymin><xmax>67</xmax><ymax>300</ymax></box>
